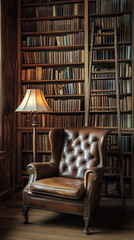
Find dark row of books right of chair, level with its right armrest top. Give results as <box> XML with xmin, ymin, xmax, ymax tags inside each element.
<box><xmin>105</xmin><ymin>156</ymin><xmax>131</xmax><ymax>177</ymax></box>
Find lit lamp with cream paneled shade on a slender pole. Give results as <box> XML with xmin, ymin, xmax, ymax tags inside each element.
<box><xmin>15</xmin><ymin>89</ymin><xmax>51</xmax><ymax>162</ymax></box>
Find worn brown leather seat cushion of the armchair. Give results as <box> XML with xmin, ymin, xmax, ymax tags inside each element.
<box><xmin>30</xmin><ymin>177</ymin><xmax>84</xmax><ymax>199</ymax></box>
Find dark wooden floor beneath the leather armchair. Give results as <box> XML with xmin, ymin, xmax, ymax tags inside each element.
<box><xmin>0</xmin><ymin>193</ymin><xmax>134</xmax><ymax>240</ymax></box>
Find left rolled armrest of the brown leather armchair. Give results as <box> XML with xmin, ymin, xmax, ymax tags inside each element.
<box><xmin>27</xmin><ymin>162</ymin><xmax>57</xmax><ymax>182</ymax></box>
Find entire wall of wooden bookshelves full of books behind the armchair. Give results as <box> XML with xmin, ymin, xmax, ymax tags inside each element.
<box><xmin>17</xmin><ymin>0</ymin><xmax>134</xmax><ymax>196</ymax></box>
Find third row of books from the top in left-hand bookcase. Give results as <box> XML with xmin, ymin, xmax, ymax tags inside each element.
<box><xmin>22</xmin><ymin>32</ymin><xmax>84</xmax><ymax>47</ymax></box>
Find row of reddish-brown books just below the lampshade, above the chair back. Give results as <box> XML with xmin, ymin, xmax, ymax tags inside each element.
<box><xmin>21</xmin><ymin>113</ymin><xmax>85</xmax><ymax>127</ymax></box>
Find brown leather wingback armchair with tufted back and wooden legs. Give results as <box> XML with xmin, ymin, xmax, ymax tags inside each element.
<box><xmin>23</xmin><ymin>127</ymin><xmax>108</xmax><ymax>234</ymax></box>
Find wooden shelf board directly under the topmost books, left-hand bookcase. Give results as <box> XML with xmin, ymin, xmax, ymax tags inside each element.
<box><xmin>21</xmin><ymin>15</ymin><xmax>84</xmax><ymax>22</ymax></box>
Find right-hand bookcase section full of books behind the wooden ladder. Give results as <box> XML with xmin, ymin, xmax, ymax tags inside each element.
<box><xmin>85</xmin><ymin>0</ymin><xmax>134</xmax><ymax>197</ymax></box>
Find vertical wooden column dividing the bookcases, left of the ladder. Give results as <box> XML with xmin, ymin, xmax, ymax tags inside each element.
<box><xmin>84</xmin><ymin>0</ymin><xmax>89</xmax><ymax>126</ymax></box>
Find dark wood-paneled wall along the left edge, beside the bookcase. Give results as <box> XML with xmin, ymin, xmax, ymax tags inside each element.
<box><xmin>0</xmin><ymin>0</ymin><xmax>17</xmax><ymax>200</ymax></box>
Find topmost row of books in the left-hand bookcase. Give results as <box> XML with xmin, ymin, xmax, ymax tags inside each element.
<box><xmin>22</xmin><ymin>2</ymin><xmax>84</xmax><ymax>18</ymax></box>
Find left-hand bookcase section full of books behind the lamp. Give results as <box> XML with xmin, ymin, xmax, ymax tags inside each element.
<box><xmin>17</xmin><ymin>0</ymin><xmax>85</xmax><ymax>184</ymax></box>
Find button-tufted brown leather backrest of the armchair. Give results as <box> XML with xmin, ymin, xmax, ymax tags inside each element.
<box><xmin>58</xmin><ymin>127</ymin><xmax>106</xmax><ymax>179</ymax></box>
